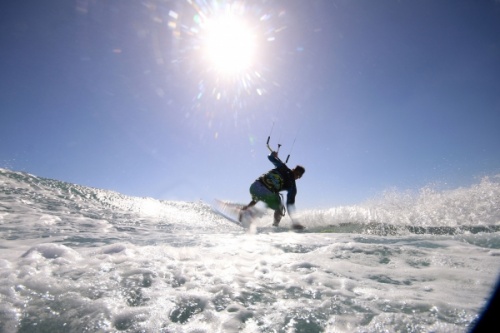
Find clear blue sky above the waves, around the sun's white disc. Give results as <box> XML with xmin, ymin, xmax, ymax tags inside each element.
<box><xmin>0</xmin><ymin>0</ymin><xmax>500</xmax><ymax>209</ymax></box>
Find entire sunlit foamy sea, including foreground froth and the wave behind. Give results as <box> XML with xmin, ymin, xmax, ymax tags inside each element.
<box><xmin>0</xmin><ymin>169</ymin><xmax>500</xmax><ymax>332</ymax></box>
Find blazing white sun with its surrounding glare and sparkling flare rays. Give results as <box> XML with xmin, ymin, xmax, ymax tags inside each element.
<box><xmin>168</xmin><ymin>0</ymin><xmax>286</xmax><ymax>109</ymax></box>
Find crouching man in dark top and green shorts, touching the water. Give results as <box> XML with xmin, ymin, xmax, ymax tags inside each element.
<box><xmin>239</xmin><ymin>151</ymin><xmax>306</xmax><ymax>229</ymax></box>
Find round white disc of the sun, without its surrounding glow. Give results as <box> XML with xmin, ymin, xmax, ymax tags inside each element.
<box><xmin>204</xmin><ymin>15</ymin><xmax>255</xmax><ymax>75</ymax></box>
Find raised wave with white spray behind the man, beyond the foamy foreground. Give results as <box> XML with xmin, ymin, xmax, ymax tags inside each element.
<box><xmin>0</xmin><ymin>169</ymin><xmax>500</xmax><ymax>239</ymax></box>
